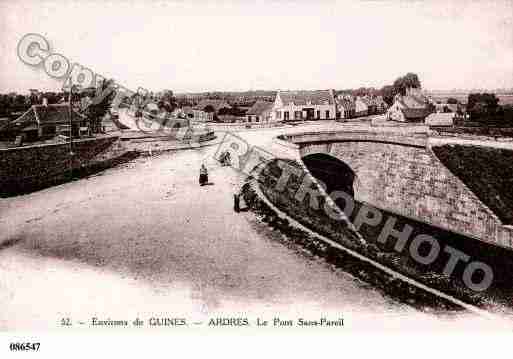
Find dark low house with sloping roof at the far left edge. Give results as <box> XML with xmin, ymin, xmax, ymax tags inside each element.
<box><xmin>0</xmin><ymin>99</ymin><xmax>92</xmax><ymax>142</ymax></box>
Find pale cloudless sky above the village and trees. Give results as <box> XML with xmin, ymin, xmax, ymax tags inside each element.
<box><xmin>0</xmin><ymin>0</ymin><xmax>513</xmax><ymax>93</ymax></box>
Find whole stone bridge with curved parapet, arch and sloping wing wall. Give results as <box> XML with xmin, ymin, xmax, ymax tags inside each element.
<box><xmin>272</xmin><ymin>131</ymin><xmax>513</xmax><ymax>249</ymax></box>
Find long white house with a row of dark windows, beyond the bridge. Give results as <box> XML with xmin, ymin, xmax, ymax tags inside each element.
<box><xmin>272</xmin><ymin>90</ymin><xmax>336</xmax><ymax>121</ymax></box>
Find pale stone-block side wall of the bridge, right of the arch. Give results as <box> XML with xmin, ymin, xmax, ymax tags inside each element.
<box><xmin>292</xmin><ymin>136</ymin><xmax>513</xmax><ymax>248</ymax></box>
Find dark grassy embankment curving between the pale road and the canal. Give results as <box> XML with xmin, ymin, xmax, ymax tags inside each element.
<box><xmin>243</xmin><ymin>160</ymin><xmax>500</xmax><ymax>307</ymax></box>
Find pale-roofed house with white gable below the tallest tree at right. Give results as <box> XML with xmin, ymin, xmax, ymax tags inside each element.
<box><xmin>387</xmin><ymin>88</ymin><xmax>433</xmax><ymax>122</ymax></box>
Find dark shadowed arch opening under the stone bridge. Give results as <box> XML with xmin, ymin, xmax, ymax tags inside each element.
<box><xmin>302</xmin><ymin>153</ymin><xmax>356</xmax><ymax>197</ymax></box>
